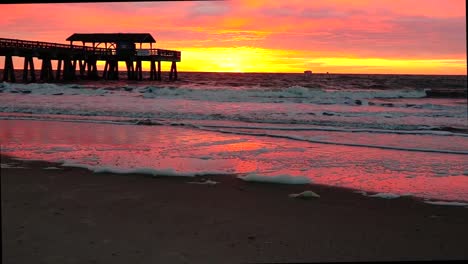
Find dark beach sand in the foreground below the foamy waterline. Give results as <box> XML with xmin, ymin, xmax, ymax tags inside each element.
<box><xmin>1</xmin><ymin>156</ymin><xmax>468</xmax><ymax>264</ymax></box>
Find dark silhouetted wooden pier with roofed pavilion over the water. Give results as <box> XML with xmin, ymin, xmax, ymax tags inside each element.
<box><xmin>0</xmin><ymin>33</ymin><xmax>181</xmax><ymax>82</ymax></box>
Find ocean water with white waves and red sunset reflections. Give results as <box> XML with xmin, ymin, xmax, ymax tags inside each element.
<box><xmin>0</xmin><ymin>72</ymin><xmax>468</xmax><ymax>202</ymax></box>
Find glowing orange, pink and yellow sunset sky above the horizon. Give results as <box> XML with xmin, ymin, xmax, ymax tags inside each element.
<box><xmin>0</xmin><ymin>0</ymin><xmax>467</xmax><ymax>75</ymax></box>
